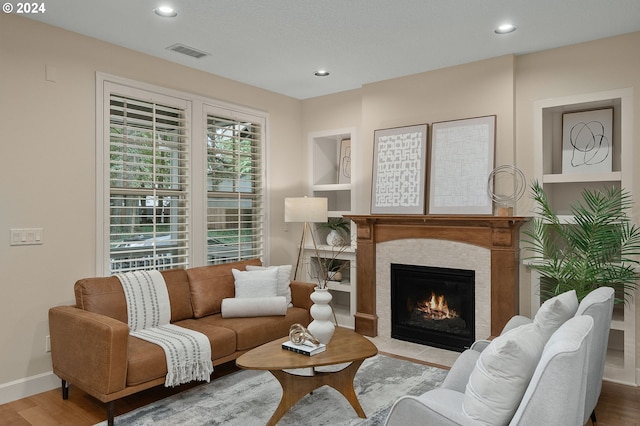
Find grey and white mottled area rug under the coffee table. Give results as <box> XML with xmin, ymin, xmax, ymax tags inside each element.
<box><xmin>100</xmin><ymin>355</ymin><xmax>447</xmax><ymax>426</ymax></box>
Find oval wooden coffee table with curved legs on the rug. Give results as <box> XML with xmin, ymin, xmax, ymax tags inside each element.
<box><xmin>236</xmin><ymin>327</ymin><xmax>378</xmax><ymax>426</ymax></box>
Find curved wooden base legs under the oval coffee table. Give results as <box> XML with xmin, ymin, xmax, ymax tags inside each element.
<box><xmin>267</xmin><ymin>360</ymin><xmax>367</xmax><ymax>426</ymax></box>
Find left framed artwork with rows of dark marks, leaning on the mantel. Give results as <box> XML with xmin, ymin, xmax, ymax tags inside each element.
<box><xmin>371</xmin><ymin>124</ymin><xmax>428</xmax><ymax>214</ymax></box>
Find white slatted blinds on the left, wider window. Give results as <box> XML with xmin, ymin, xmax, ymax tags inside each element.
<box><xmin>106</xmin><ymin>93</ymin><xmax>190</xmax><ymax>273</ymax></box>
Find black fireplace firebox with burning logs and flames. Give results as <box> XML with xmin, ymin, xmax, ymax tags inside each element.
<box><xmin>391</xmin><ymin>263</ymin><xmax>475</xmax><ymax>352</ymax></box>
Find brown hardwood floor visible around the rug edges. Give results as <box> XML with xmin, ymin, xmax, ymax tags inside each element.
<box><xmin>0</xmin><ymin>361</ymin><xmax>640</xmax><ymax>426</ymax></box>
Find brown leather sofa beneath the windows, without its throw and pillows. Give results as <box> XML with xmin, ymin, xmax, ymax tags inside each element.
<box><xmin>49</xmin><ymin>259</ymin><xmax>314</xmax><ymax>425</ymax></box>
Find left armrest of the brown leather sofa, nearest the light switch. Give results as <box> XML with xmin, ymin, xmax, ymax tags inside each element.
<box><xmin>49</xmin><ymin>306</ymin><xmax>129</xmax><ymax>399</ymax></box>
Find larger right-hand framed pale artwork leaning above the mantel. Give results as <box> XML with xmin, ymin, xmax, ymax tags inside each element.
<box><xmin>429</xmin><ymin>115</ymin><xmax>496</xmax><ymax>214</ymax></box>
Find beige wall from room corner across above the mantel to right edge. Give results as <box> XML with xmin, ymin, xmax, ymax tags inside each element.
<box><xmin>303</xmin><ymin>33</ymin><xmax>640</xmax><ymax>372</ymax></box>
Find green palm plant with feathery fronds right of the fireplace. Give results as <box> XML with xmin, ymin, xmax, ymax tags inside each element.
<box><xmin>523</xmin><ymin>181</ymin><xmax>640</xmax><ymax>303</ymax></box>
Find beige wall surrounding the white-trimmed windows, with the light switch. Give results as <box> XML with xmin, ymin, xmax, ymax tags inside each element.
<box><xmin>0</xmin><ymin>14</ymin><xmax>306</xmax><ymax>396</ymax></box>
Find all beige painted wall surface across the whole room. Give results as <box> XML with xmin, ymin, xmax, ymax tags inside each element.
<box><xmin>0</xmin><ymin>2</ymin><xmax>640</xmax><ymax>422</ymax></box>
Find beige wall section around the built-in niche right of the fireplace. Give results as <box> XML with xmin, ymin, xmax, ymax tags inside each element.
<box><xmin>515</xmin><ymin>32</ymin><xmax>640</xmax><ymax>362</ymax></box>
